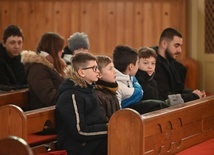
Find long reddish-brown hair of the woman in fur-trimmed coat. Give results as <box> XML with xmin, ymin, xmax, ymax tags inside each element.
<box><xmin>36</xmin><ymin>32</ymin><xmax>64</xmax><ymax>74</ymax></box>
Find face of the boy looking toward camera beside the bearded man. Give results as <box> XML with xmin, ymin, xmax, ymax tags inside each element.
<box><xmin>138</xmin><ymin>56</ymin><xmax>156</xmax><ymax>76</ymax></box>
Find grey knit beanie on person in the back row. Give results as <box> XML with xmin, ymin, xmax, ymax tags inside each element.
<box><xmin>68</xmin><ymin>32</ymin><xmax>90</xmax><ymax>52</ymax></box>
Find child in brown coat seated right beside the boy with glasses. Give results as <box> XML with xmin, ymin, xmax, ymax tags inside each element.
<box><xmin>95</xmin><ymin>56</ymin><xmax>120</xmax><ymax>122</ymax></box>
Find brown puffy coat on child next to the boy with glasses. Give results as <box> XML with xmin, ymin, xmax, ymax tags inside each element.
<box><xmin>95</xmin><ymin>80</ymin><xmax>120</xmax><ymax>122</ymax></box>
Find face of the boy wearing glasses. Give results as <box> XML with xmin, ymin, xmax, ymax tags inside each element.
<box><xmin>81</xmin><ymin>60</ymin><xmax>99</xmax><ymax>84</ymax></box>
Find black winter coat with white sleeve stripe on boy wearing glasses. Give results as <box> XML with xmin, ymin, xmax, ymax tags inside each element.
<box><xmin>55</xmin><ymin>66</ymin><xmax>107</xmax><ymax>155</ymax></box>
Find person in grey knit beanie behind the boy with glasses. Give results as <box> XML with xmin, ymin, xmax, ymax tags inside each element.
<box><xmin>62</xmin><ymin>32</ymin><xmax>90</xmax><ymax>65</ymax></box>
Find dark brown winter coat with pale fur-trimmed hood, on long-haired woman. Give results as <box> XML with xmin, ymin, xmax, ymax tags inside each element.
<box><xmin>22</xmin><ymin>51</ymin><xmax>63</xmax><ymax>110</ymax></box>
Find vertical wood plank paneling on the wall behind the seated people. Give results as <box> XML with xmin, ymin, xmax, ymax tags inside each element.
<box><xmin>0</xmin><ymin>0</ymin><xmax>186</xmax><ymax>57</ymax></box>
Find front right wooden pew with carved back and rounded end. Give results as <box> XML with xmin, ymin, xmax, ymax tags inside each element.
<box><xmin>108</xmin><ymin>96</ymin><xmax>214</xmax><ymax>155</ymax></box>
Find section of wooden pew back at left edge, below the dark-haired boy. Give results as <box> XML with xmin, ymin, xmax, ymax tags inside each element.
<box><xmin>0</xmin><ymin>88</ymin><xmax>29</xmax><ymax>109</ymax></box>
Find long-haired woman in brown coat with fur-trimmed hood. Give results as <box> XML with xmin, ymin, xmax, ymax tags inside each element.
<box><xmin>22</xmin><ymin>32</ymin><xmax>66</xmax><ymax>110</ymax></box>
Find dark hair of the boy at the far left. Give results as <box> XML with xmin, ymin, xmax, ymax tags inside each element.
<box><xmin>3</xmin><ymin>25</ymin><xmax>24</xmax><ymax>42</ymax></box>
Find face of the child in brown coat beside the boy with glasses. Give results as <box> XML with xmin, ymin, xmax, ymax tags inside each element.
<box><xmin>99</xmin><ymin>63</ymin><xmax>116</xmax><ymax>83</ymax></box>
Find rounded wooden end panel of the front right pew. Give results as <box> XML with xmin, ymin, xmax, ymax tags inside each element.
<box><xmin>108</xmin><ymin>109</ymin><xmax>144</xmax><ymax>155</ymax></box>
